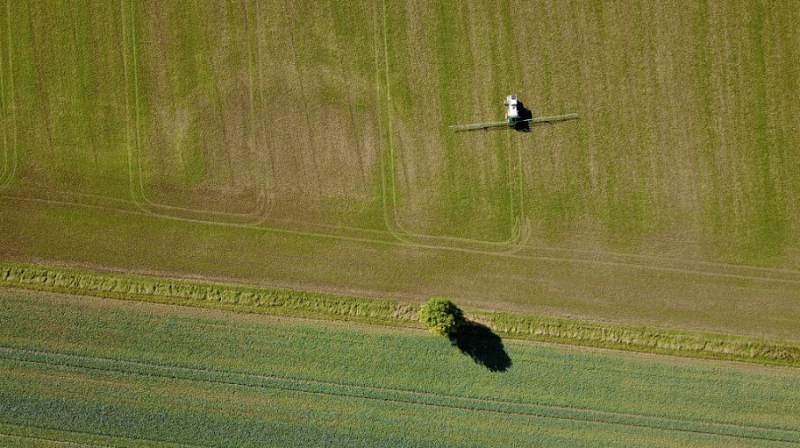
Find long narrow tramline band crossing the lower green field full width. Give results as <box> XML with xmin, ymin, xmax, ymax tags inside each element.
<box><xmin>0</xmin><ymin>347</ymin><xmax>800</xmax><ymax>444</ymax></box>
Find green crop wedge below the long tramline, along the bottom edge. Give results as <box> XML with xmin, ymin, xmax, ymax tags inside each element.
<box><xmin>0</xmin><ymin>362</ymin><xmax>716</xmax><ymax>447</ymax></box>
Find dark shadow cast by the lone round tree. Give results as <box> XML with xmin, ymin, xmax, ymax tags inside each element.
<box><xmin>449</xmin><ymin>321</ymin><xmax>511</xmax><ymax>372</ymax></box>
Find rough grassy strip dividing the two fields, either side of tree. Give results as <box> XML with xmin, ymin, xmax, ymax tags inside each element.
<box><xmin>0</xmin><ymin>262</ymin><xmax>800</xmax><ymax>367</ymax></box>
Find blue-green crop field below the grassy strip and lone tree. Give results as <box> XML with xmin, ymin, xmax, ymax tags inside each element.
<box><xmin>0</xmin><ymin>290</ymin><xmax>800</xmax><ymax>447</ymax></box>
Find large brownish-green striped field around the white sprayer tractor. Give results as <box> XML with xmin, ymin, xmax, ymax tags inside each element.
<box><xmin>0</xmin><ymin>0</ymin><xmax>800</xmax><ymax>340</ymax></box>
